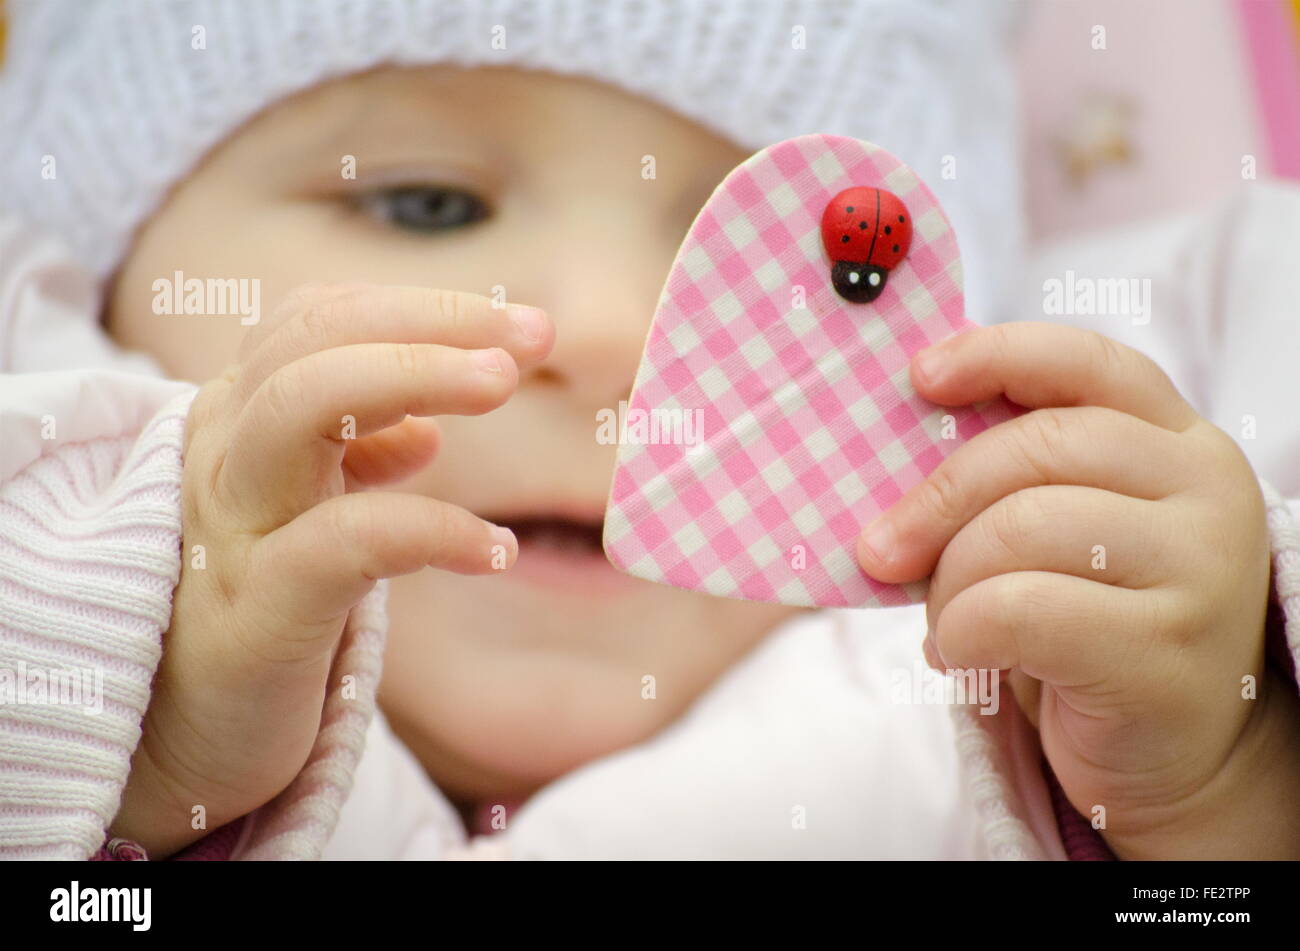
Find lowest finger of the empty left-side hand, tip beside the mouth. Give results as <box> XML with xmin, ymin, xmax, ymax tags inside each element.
<box><xmin>251</xmin><ymin>491</ymin><xmax>519</xmax><ymax>638</ymax></box>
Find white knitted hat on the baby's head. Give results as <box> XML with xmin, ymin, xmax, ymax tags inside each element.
<box><xmin>0</xmin><ymin>0</ymin><xmax>1022</xmax><ymax>321</ymax></box>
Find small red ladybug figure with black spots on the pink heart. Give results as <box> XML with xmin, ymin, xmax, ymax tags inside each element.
<box><xmin>822</xmin><ymin>186</ymin><xmax>911</xmax><ymax>304</ymax></box>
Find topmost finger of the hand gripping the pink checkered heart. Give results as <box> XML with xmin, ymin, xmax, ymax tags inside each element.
<box><xmin>911</xmin><ymin>322</ymin><xmax>1199</xmax><ymax>433</ymax></box>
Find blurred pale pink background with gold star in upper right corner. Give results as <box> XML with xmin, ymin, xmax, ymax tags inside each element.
<box><xmin>1018</xmin><ymin>0</ymin><xmax>1284</xmax><ymax>240</ymax></box>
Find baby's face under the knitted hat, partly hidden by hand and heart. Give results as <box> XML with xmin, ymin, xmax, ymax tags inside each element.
<box><xmin>107</xmin><ymin>68</ymin><xmax>789</xmax><ymax>800</ymax></box>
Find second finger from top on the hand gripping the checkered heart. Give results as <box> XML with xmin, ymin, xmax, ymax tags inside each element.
<box><xmin>858</xmin><ymin>407</ymin><xmax>1195</xmax><ymax>583</ymax></box>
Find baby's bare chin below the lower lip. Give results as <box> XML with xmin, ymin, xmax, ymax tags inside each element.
<box><xmin>381</xmin><ymin>569</ymin><xmax>793</xmax><ymax>802</ymax></box>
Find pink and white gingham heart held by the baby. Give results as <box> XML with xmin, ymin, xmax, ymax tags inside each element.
<box><xmin>605</xmin><ymin>135</ymin><xmax>1019</xmax><ymax>607</ymax></box>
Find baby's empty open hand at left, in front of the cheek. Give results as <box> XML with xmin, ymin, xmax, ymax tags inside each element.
<box><xmin>112</xmin><ymin>285</ymin><xmax>554</xmax><ymax>857</ymax></box>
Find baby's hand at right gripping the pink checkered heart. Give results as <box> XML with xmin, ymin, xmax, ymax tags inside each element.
<box><xmin>859</xmin><ymin>323</ymin><xmax>1300</xmax><ymax>859</ymax></box>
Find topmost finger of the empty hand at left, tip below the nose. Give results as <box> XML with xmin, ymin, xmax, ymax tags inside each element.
<box><xmin>235</xmin><ymin>285</ymin><xmax>555</xmax><ymax>400</ymax></box>
